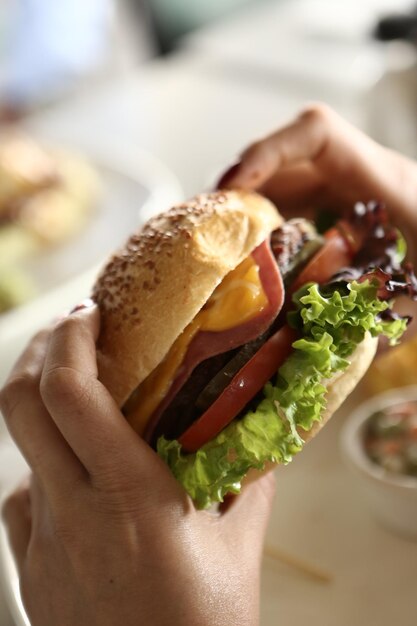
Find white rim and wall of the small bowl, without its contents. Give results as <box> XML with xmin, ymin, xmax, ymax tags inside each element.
<box><xmin>341</xmin><ymin>386</ymin><xmax>417</xmax><ymax>540</ymax></box>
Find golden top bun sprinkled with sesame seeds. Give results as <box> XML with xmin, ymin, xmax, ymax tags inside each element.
<box><xmin>92</xmin><ymin>191</ymin><xmax>283</xmax><ymax>406</ymax></box>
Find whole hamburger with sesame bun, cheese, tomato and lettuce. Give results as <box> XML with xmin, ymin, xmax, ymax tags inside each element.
<box><xmin>93</xmin><ymin>191</ymin><xmax>417</xmax><ymax>508</ymax></box>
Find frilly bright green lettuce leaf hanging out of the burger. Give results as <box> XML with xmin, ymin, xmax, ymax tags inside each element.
<box><xmin>158</xmin><ymin>281</ymin><xmax>407</xmax><ymax>508</ymax></box>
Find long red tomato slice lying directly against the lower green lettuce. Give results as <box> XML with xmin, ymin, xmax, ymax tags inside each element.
<box><xmin>179</xmin><ymin>326</ymin><xmax>297</xmax><ymax>452</ymax></box>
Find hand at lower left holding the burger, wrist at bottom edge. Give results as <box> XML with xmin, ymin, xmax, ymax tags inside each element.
<box><xmin>0</xmin><ymin>307</ymin><xmax>273</xmax><ymax>626</ymax></box>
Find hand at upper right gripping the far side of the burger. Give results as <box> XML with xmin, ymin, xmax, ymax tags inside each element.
<box><xmin>218</xmin><ymin>104</ymin><xmax>417</xmax><ymax>265</ymax></box>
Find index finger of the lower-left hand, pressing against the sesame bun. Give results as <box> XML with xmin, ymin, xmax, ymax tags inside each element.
<box><xmin>40</xmin><ymin>306</ymin><xmax>169</xmax><ymax>476</ymax></box>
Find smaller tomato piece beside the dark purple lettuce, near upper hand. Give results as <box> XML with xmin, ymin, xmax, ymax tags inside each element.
<box><xmin>291</xmin><ymin>228</ymin><xmax>353</xmax><ymax>293</ymax></box>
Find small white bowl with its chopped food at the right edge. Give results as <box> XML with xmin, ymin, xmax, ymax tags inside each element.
<box><xmin>340</xmin><ymin>385</ymin><xmax>417</xmax><ymax>539</ymax></box>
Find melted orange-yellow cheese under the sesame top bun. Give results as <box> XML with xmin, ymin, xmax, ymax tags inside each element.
<box><xmin>126</xmin><ymin>256</ymin><xmax>268</xmax><ymax>434</ymax></box>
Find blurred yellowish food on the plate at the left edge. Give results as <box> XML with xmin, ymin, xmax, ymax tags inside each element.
<box><xmin>0</xmin><ymin>131</ymin><xmax>100</xmax><ymax>313</ymax></box>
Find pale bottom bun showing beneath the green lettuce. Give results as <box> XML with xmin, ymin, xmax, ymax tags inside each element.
<box><xmin>242</xmin><ymin>333</ymin><xmax>378</xmax><ymax>486</ymax></box>
